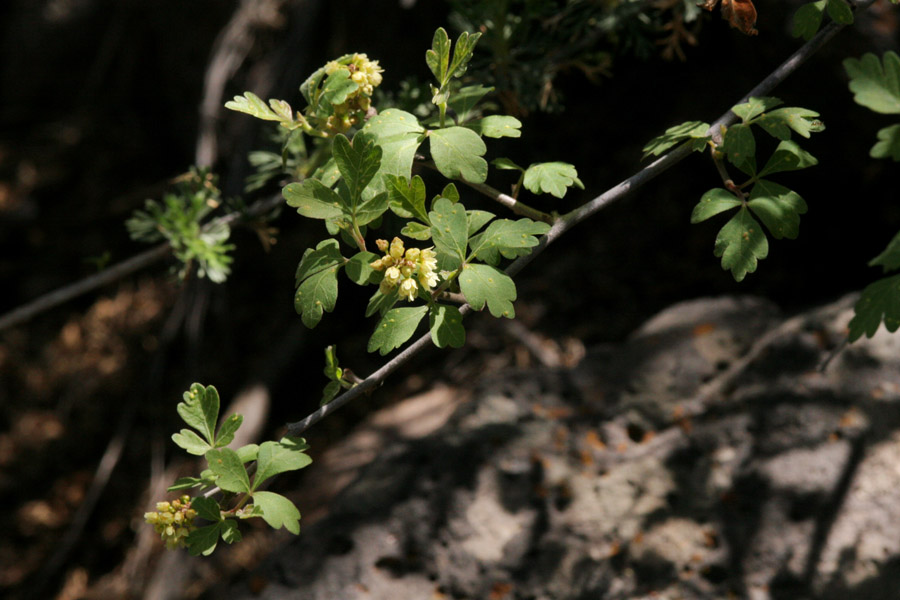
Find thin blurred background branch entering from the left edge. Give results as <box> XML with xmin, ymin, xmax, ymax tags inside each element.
<box><xmin>0</xmin><ymin>194</ymin><xmax>283</xmax><ymax>331</ymax></box>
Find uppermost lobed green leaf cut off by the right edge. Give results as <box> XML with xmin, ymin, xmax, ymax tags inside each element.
<box><xmin>844</xmin><ymin>52</ymin><xmax>900</xmax><ymax>114</ymax></box>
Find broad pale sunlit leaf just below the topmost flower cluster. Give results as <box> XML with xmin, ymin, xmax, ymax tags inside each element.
<box><xmin>362</xmin><ymin>108</ymin><xmax>425</xmax><ymax>191</ymax></box>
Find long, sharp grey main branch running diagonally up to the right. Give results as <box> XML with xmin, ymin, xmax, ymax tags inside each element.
<box><xmin>287</xmin><ymin>0</ymin><xmax>875</xmax><ymax>436</ymax></box>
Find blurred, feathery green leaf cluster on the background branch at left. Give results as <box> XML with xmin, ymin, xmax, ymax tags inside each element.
<box><xmin>125</xmin><ymin>169</ymin><xmax>234</xmax><ymax>283</ymax></box>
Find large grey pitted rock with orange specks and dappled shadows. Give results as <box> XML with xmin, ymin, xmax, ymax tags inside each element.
<box><xmin>222</xmin><ymin>298</ymin><xmax>900</xmax><ymax>600</ymax></box>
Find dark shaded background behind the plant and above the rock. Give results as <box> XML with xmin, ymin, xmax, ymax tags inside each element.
<box><xmin>0</xmin><ymin>0</ymin><xmax>900</xmax><ymax>597</ymax></box>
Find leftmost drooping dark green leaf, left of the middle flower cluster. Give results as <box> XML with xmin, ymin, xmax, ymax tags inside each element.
<box><xmin>294</xmin><ymin>239</ymin><xmax>345</xmax><ymax>328</ymax></box>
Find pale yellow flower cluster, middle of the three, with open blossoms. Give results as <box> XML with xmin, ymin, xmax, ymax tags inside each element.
<box><xmin>371</xmin><ymin>238</ymin><xmax>438</xmax><ymax>302</ymax></box>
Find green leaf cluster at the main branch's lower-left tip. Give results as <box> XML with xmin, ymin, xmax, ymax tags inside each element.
<box><xmin>169</xmin><ymin>383</ymin><xmax>312</xmax><ymax>555</ymax></box>
